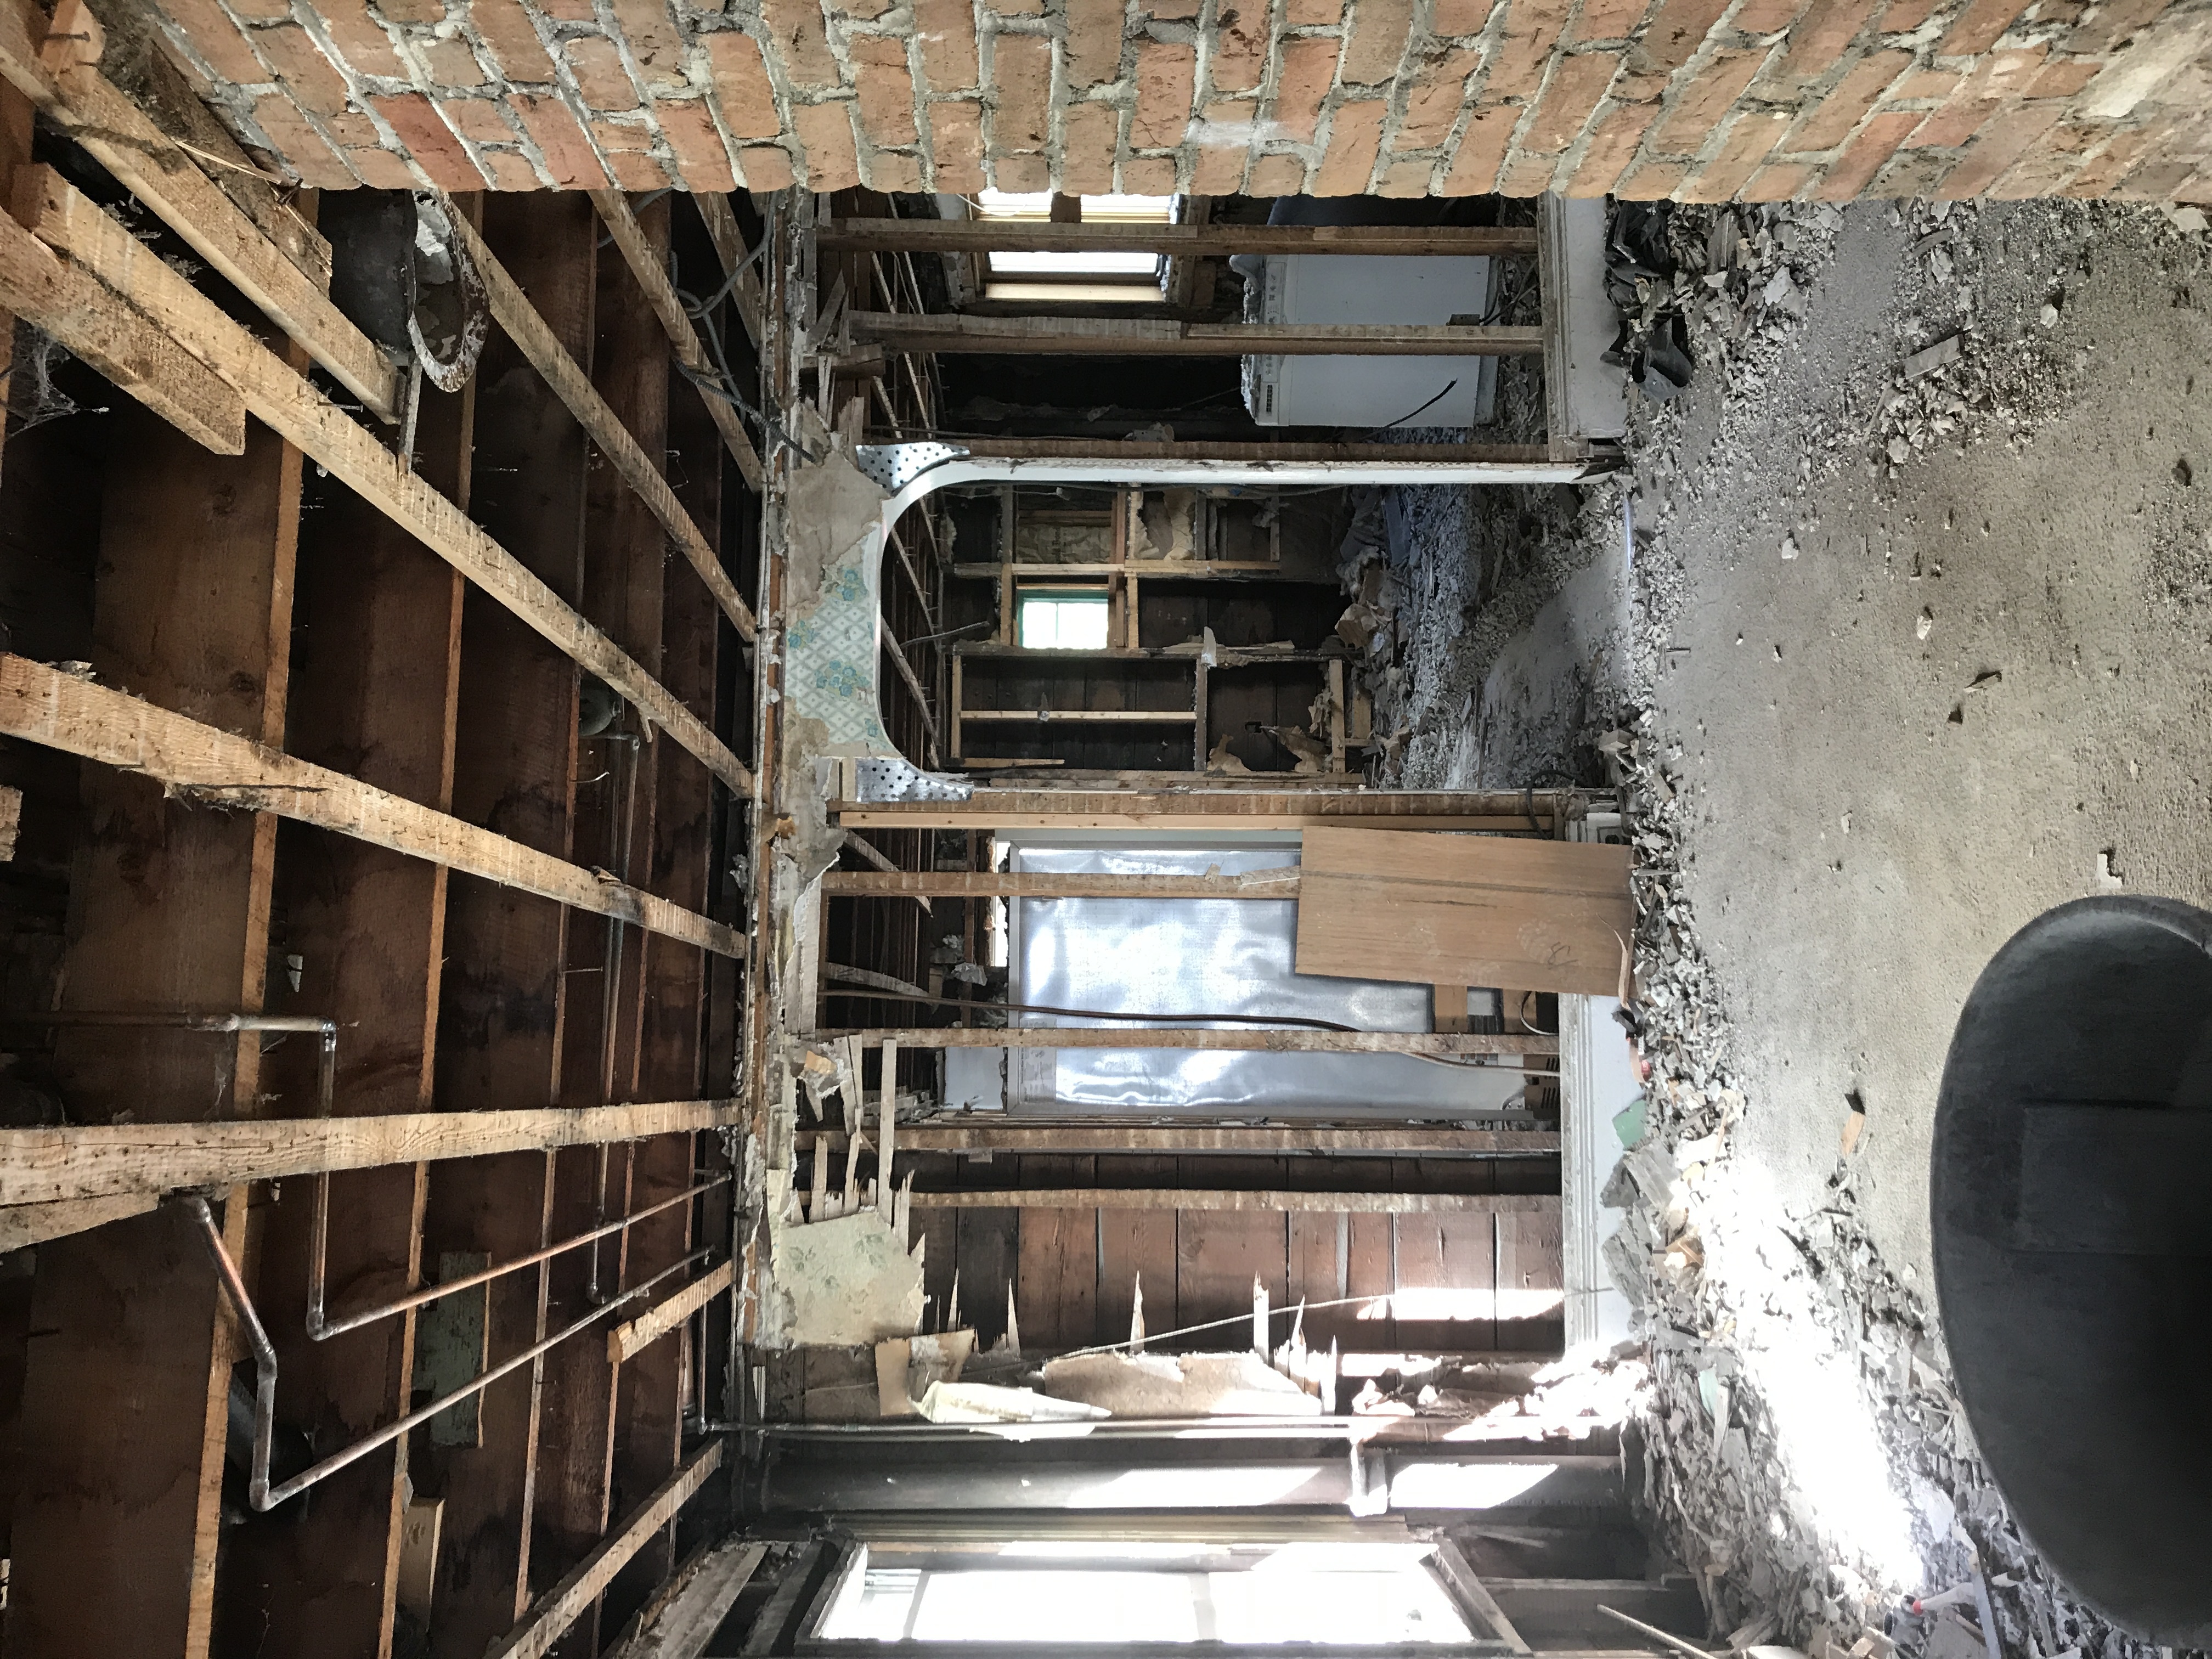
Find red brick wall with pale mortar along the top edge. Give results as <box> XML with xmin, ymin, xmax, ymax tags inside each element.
<box><xmin>148</xmin><ymin>0</ymin><xmax>2212</xmax><ymax>201</ymax></box>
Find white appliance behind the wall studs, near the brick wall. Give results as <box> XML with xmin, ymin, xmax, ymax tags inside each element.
<box><xmin>1243</xmin><ymin>255</ymin><xmax>1498</xmax><ymax>429</ymax></box>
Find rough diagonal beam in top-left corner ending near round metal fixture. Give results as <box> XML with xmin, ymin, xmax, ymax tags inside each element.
<box><xmin>0</xmin><ymin>0</ymin><xmax>398</xmax><ymax>420</ymax></box>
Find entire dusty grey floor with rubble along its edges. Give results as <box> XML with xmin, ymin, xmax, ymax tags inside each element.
<box><xmin>1378</xmin><ymin>204</ymin><xmax>2212</xmax><ymax>1655</ymax></box>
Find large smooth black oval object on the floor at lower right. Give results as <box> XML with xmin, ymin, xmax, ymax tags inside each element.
<box><xmin>1929</xmin><ymin>898</ymin><xmax>2212</xmax><ymax>1648</ymax></box>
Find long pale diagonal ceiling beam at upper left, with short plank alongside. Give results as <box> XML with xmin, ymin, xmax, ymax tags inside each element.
<box><xmin>0</xmin><ymin>166</ymin><xmax>752</xmax><ymax>794</ymax></box>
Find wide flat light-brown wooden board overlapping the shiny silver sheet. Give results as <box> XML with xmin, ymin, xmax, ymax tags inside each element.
<box><xmin>1296</xmin><ymin>827</ymin><xmax>1637</xmax><ymax>995</ymax></box>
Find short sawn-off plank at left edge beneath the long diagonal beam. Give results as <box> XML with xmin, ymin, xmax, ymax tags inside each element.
<box><xmin>0</xmin><ymin>182</ymin><xmax>246</xmax><ymax>456</ymax></box>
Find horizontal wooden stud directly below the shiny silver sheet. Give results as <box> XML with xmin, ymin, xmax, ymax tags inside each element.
<box><xmin>794</xmin><ymin>1121</ymin><xmax>1560</xmax><ymax>1157</ymax></box>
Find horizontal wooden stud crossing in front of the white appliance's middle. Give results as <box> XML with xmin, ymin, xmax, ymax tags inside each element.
<box><xmin>845</xmin><ymin>316</ymin><xmax>1544</xmax><ymax>356</ymax></box>
